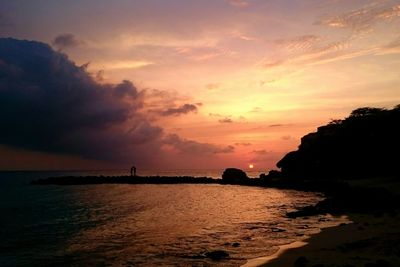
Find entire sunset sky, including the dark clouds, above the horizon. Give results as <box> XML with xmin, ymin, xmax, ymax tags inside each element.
<box><xmin>0</xmin><ymin>0</ymin><xmax>400</xmax><ymax>172</ymax></box>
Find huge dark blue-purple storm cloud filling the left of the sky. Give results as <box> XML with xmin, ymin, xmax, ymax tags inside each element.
<box><xmin>0</xmin><ymin>38</ymin><xmax>163</xmax><ymax>163</ymax></box>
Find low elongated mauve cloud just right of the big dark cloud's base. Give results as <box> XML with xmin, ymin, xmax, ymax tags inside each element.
<box><xmin>163</xmin><ymin>134</ymin><xmax>235</xmax><ymax>155</ymax></box>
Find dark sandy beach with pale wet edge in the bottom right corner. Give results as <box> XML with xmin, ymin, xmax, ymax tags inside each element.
<box><xmin>253</xmin><ymin>213</ymin><xmax>400</xmax><ymax>267</ymax></box>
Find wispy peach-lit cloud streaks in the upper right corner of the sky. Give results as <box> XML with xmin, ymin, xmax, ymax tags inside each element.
<box><xmin>259</xmin><ymin>1</ymin><xmax>400</xmax><ymax>69</ymax></box>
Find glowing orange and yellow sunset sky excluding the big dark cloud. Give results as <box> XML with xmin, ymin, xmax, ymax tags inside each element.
<box><xmin>0</xmin><ymin>0</ymin><xmax>400</xmax><ymax>170</ymax></box>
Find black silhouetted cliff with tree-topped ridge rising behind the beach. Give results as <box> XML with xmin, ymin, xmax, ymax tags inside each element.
<box><xmin>277</xmin><ymin>105</ymin><xmax>400</xmax><ymax>179</ymax></box>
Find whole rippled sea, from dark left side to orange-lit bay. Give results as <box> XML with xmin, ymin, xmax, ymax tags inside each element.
<box><xmin>0</xmin><ymin>171</ymin><xmax>343</xmax><ymax>266</ymax></box>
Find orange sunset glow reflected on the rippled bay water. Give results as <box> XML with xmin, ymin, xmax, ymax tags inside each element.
<box><xmin>56</xmin><ymin>185</ymin><xmax>344</xmax><ymax>266</ymax></box>
